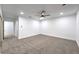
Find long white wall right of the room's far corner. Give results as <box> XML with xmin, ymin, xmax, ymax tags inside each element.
<box><xmin>41</xmin><ymin>15</ymin><xmax>76</xmax><ymax>40</ymax></box>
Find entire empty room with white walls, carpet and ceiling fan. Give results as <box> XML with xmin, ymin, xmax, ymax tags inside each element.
<box><xmin>0</xmin><ymin>4</ymin><xmax>79</xmax><ymax>54</ymax></box>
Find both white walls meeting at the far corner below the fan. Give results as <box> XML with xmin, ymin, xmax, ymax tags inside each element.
<box><xmin>19</xmin><ymin>14</ymin><xmax>76</xmax><ymax>40</ymax></box>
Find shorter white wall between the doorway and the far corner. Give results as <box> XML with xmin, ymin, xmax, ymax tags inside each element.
<box><xmin>19</xmin><ymin>17</ymin><xmax>39</xmax><ymax>39</ymax></box>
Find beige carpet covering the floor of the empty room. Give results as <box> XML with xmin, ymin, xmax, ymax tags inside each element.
<box><xmin>2</xmin><ymin>34</ymin><xmax>79</xmax><ymax>54</ymax></box>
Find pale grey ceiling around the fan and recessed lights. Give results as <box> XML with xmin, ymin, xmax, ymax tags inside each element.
<box><xmin>2</xmin><ymin>4</ymin><xmax>79</xmax><ymax>19</ymax></box>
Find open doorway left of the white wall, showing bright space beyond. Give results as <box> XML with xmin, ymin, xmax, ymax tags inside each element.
<box><xmin>4</xmin><ymin>17</ymin><xmax>18</xmax><ymax>40</ymax></box>
